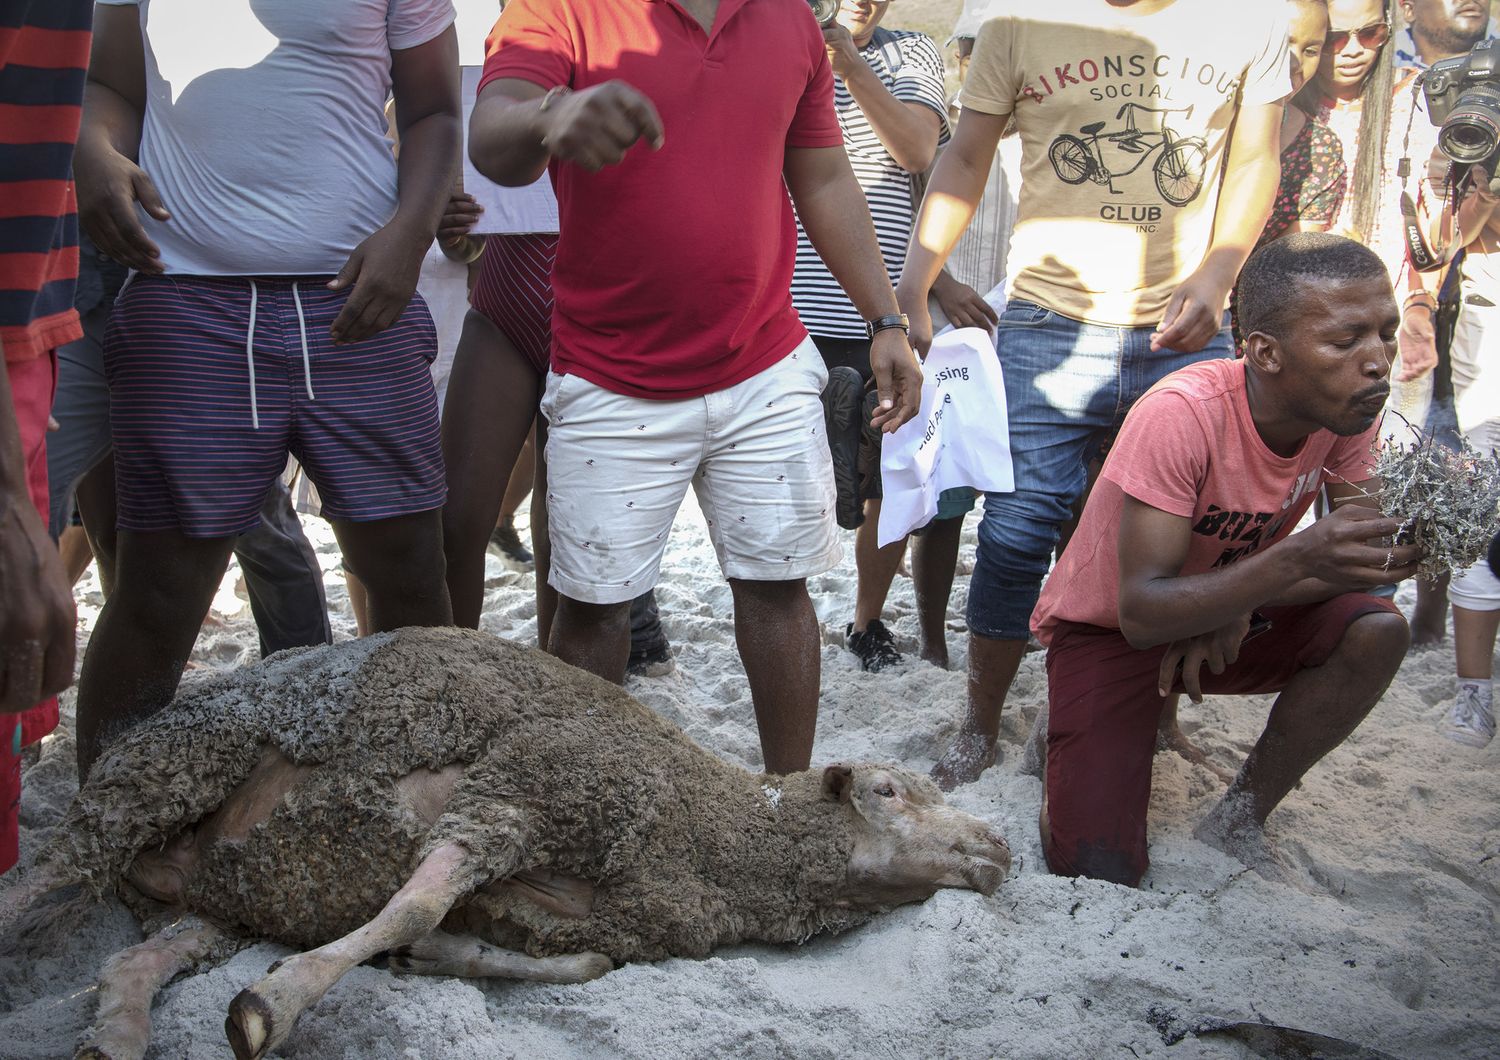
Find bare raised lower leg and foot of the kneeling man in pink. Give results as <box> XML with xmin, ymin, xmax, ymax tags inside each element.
<box><xmin>1194</xmin><ymin>612</ymin><xmax>1410</xmax><ymax>868</ymax></box>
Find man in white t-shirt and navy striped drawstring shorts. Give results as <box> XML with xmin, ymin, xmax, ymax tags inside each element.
<box><xmin>77</xmin><ymin>0</ymin><xmax>459</xmax><ymax>774</ymax></box>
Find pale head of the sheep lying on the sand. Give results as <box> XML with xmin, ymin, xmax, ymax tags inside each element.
<box><xmin>824</xmin><ymin>765</ymin><xmax>1011</xmax><ymax>909</ymax></box>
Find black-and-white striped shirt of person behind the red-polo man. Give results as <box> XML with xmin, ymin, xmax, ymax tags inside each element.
<box><xmin>792</xmin><ymin>28</ymin><xmax>948</xmax><ymax>339</ymax></box>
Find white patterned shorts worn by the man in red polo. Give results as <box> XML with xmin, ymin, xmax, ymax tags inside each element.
<box><xmin>542</xmin><ymin>339</ymin><xmax>842</xmax><ymax>604</ymax></box>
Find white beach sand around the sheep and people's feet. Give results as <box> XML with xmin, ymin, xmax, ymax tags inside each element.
<box><xmin>0</xmin><ymin>501</ymin><xmax>1500</xmax><ymax>1060</ymax></box>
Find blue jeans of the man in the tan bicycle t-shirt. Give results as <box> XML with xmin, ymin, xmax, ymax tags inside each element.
<box><xmin>969</xmin><ymin>298</ymin><xmax>1233</xmax><ymax>640</ymax></box>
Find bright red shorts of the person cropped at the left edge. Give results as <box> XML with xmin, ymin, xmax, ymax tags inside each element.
<box><xmin>0</xmin><ymin>354</ymin><xmax>57</xmax><ymax>873</ymax></box>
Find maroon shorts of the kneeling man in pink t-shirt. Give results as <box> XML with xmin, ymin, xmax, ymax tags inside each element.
<box><xmin>1044</xmin><ymin>592</ymin><xmax>1400</xmax><ymax>886</ymax></box>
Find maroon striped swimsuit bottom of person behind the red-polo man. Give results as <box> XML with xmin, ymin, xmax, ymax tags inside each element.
<box><xmin>473</xmin><ymin>232</ymin><xmax>558</xmax><ymax>375</ymax></box>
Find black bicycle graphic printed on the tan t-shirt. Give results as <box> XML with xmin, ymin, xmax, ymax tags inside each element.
<box><xmin>1047</xmin><ymin>103</ymin><xmax>1208</xmax><ymax>205</ymax></box>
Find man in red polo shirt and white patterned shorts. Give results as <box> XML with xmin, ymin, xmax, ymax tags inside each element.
<box><xmin>470</xmin><ymin>0</ymin><xmax>921</xmax><ymax>772</ymax></box>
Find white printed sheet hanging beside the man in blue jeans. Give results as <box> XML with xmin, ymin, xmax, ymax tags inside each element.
<box><xmin>878</xmin><ymin>327</ymin><xmax>1016</xmax><ymax>547</ymax></box>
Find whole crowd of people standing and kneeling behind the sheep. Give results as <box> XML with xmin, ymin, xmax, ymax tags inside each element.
<box><xmin>0</xmin><ymin>0</ymin><xmax>1500</xmax><ymax>885</ymax></box>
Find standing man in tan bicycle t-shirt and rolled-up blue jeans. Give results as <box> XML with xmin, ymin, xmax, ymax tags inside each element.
<box><xmin>897</xmin><ymin>0</ymin><xmax>1292</xmax><ymax>787</ymax></box>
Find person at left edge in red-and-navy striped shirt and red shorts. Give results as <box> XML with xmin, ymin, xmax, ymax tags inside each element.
<box><xmin>0</xmin><ymin>0</ymin><xmax>93</xmax><ymax>873</ymax></box>
